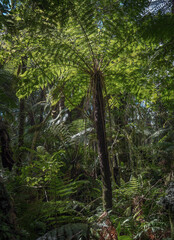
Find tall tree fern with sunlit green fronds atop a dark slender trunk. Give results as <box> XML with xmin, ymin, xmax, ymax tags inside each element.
<box><xmin>3</xmin><ymin>0</ymin><xmax>154</xmax><ymax>209</ymax></box>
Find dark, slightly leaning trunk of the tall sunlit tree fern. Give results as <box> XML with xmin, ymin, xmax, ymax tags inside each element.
<box><xmin>92</xmin><ymin>71</ymin><xmax>112</xmax><ymax>210</ymax></box>
